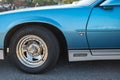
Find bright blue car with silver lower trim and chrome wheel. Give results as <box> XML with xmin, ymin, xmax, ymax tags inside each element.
<box><xmin>0</xmin><ymin>0</ymin><xmax>120</xmax><ymax>73</ymax></box>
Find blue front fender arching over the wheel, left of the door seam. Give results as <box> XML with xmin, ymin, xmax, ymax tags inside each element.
<box><xmin>0</xmin><ymin>6</ymin><xmax>92</xmax><ymax>49</ymax></box>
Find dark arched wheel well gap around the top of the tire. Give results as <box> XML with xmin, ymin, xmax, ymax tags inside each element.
<box><xmin>4</xmin><ymin>23</ymin><xmax>67</xmax><ymax>56</ymax></box>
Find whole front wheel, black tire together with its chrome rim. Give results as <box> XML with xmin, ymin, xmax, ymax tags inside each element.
<box><xmin>9</xmin><ymin>25</ymin><xmax>60</xmax><ymax>74</ymax></box>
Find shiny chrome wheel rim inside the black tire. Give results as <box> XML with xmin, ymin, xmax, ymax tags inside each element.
<box><xmin>16</xmin><ymin>35</ymin><xmax>48</xmax><ymax>68</ymax></box>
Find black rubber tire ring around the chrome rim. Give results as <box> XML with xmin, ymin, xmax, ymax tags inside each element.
<box><xmin>9</xmin><ymin>25</ymin><xmax>59</xmax><ymax>73</ymax></box>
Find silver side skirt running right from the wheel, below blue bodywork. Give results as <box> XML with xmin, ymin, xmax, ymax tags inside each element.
<box><xmin>68</xmin><ymin>49</ymin><xmax>120</xmax><ymax>62</ymax></box>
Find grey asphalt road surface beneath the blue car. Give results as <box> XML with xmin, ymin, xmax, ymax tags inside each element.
<box><xmin>0</xmin><ymin>55</ymin><xmax>120</xmax><ymax>80</ymax></box>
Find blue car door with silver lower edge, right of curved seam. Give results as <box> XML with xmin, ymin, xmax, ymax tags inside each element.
<box><xmin>87</xmin><ymin>0</ymin><xmax>120</xmax><ymax>55</ymax></box>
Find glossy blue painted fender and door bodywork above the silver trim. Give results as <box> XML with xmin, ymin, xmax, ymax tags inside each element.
<box><xmin>0</xmin><ymin>0</ymin><xmax>120</xmax><ymax>52</ymax></box>
